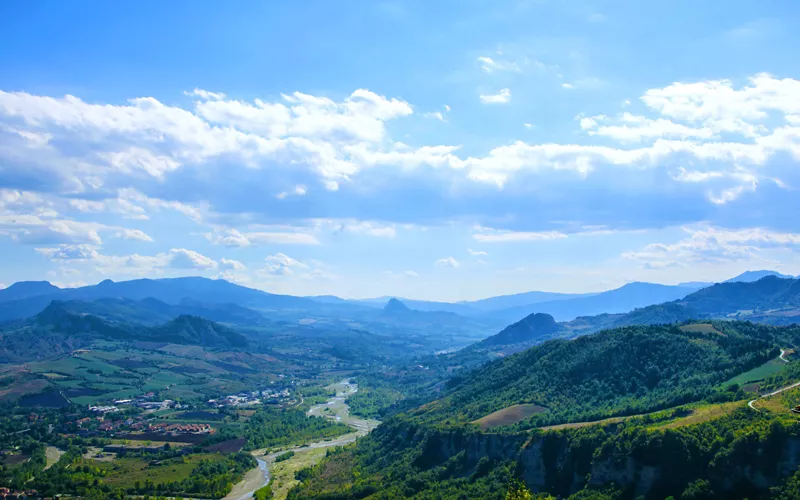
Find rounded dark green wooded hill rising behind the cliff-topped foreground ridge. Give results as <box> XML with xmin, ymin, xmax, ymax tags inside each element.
<box><xmin>411</xmin><ymin>323</ymin><xmax>788</xmax><ymax>426</ymax></box>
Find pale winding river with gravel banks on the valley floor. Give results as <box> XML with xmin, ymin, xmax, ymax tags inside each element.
<box><xmin>225</xmin><ymin>379</ymin><xmax>380</xmax><ymax>500</ymax></box>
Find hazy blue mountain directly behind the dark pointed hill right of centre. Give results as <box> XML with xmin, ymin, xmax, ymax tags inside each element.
<box><xmin>487</xmin><ymin>282</ymin><xmax>695</xmax><ymax>323</ymax></box>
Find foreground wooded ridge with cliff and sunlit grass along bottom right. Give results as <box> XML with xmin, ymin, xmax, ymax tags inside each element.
<box><xmin>289</xmin><ymin>403</ymin><xmax>800</xmax><ymax>500</ymax></box>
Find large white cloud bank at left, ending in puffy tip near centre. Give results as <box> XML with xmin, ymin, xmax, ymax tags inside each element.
<box><xmin>0</xmin><ymin>89</ymin><xmax>413</xmax><ymax>190</ymax></box>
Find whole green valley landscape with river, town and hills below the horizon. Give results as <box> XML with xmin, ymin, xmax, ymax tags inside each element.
<box><xmin>0</xmin><ymin>276</ymin><xmax>800</xmax><ymax>500</ymax></box>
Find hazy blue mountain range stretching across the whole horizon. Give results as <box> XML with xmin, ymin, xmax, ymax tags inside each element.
<box><xmin>0</xmin><ymin>271</ymin><xmax>787</xmax><ymax>343</ymax></box>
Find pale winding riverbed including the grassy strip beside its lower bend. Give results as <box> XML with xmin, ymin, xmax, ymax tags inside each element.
<box><xmin>225</xmin><ymin>379</ymin><xmax>380</xmax><ymax>500</ymax></box>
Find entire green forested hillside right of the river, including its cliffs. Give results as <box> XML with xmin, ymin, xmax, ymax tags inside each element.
<box><xmin>289</xmin><ymin>322</ymin><xmax>800</xmax><ymax>500</ymax></box>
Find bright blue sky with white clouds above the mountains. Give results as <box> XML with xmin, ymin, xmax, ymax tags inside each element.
<box><xmin>0</xmin><ymin>0</ymin><xmax>800</xmax><ymax>301</ymax></box>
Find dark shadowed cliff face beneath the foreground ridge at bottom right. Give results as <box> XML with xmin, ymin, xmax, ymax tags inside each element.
<box><xmin>376</xmin><ymin>420</ymin><xmax>800</xmax><ymax>499</ymax></box>
